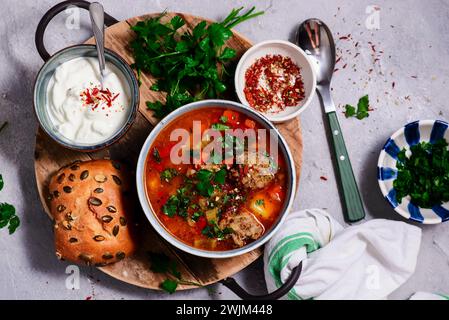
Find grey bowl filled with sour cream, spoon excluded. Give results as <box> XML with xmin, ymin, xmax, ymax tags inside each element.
<box><xmin>34</xmin><ymin>45</ymin><xmax>139</xmax><ymax>151</ymax></box>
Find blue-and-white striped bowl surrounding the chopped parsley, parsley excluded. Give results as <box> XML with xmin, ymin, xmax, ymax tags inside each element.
<box><xmin>377</xmin><ymin>120</ymin><xmax>449</xmax><ymax>224</ymax></box>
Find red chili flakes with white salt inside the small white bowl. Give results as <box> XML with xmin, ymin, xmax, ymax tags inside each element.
<box><xmin>243</xmin><ymin>55</ymin><xmax>305</xmax><ymax>113</ymax></box>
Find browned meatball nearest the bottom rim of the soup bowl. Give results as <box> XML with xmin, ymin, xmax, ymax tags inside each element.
<box><xmin>220</xmin><ymin>210</ymin><xmax>265</xmax><ymax>247</ymax></box>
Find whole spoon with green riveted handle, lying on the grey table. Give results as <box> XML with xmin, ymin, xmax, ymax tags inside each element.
<box><xmin>296</xmin><ymin>19</ymin><xmax>365</xmax><ymax>222</ymax></box>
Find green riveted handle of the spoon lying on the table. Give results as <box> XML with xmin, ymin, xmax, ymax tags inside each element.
<box><xmin>327</xmin><ymin>111</ymin><xmax>365</xmax><ymax>222</ymax></box>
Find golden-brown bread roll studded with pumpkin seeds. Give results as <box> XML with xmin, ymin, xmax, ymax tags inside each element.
<box><xmin>48</xmin><ymin>160</ymin><xmax>136</xmax><ymax>266</ymax></box>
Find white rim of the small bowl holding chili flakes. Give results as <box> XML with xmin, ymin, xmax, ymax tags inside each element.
<box><xmin>234</xmin><ymin>40</ymin><xmax>317</xmax><ymax>123</ymax></box>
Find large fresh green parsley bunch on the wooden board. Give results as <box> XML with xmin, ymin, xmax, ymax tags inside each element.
<box><xmin>130</xmin><ymin>7</ymin><xmax>263</xmax><ymax>118</ymax></box>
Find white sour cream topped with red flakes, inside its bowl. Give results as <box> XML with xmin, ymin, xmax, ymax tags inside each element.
<box><xmin>47</xmin><ymin>57</ymin><xmax>131</xmax><ymax>145</ymax></box>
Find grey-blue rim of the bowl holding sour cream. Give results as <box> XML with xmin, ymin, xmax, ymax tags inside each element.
<box><xmin>33</xmin><ymin>44</ymin><xmax>140</xmax><ymax>152</ymax></box>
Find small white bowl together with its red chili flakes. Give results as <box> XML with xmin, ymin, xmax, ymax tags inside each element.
<box><xmin>234</xmin><ymin>40</ymin><xmax>316</xmax><ymax>123</ymax></box>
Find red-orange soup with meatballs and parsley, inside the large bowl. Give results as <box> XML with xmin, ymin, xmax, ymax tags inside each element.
<box><xmin>145</xmin><ymin>107</ymin><xmax>287</xmax><ymax>251</ymax></box>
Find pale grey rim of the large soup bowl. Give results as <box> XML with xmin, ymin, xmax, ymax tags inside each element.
<box><xmin>136</xmin><ymin>99</ymin><xmax>297</xmax><ymax>258</ymax></box>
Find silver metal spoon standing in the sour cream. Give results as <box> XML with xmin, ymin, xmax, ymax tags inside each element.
<box><xmin>89</xmin><ymin>2</ymin><xmax>106</xmax><ymax>89</ymax></box>
